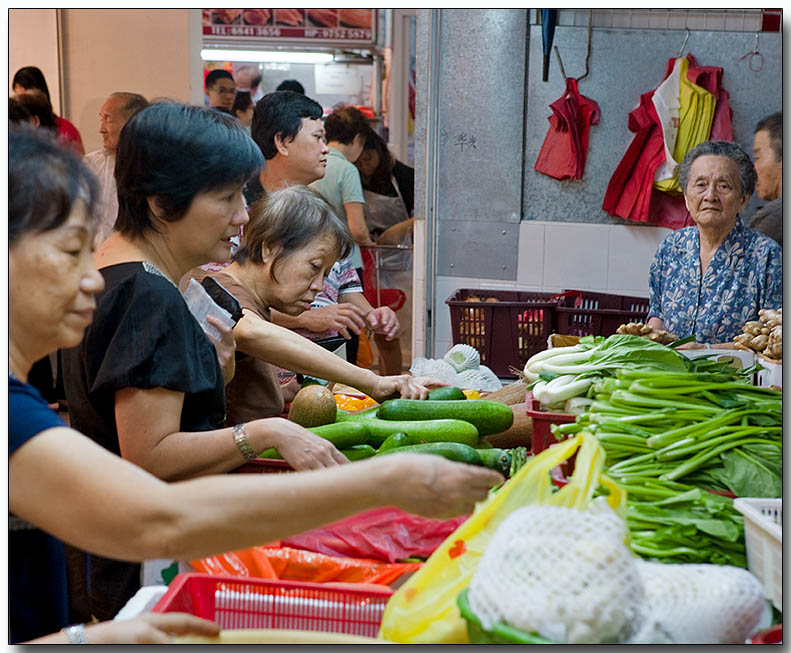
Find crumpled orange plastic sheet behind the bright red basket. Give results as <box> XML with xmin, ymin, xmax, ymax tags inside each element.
<box><xmin>190</xmin><ymin>546</ymin><xmax>423</xmax><ymax>585</ymax></box>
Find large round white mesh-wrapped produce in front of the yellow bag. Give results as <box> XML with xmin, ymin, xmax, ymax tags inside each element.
<box><xmin>468</xmin><ymin>505</ymin><xmax>642</xmax><ymax>644</ymax></box>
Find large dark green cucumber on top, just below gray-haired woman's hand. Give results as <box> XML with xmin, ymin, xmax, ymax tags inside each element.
<box><xmin>376</xmin><ymin>399</ymin><xmax>514</xmax><ymax>436</ymax></box>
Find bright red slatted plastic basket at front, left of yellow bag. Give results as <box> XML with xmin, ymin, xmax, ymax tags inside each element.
<box><xmin>152</xmin><ymin>573</ymin><xmax>393</xmax><ymax>637</ymax></box>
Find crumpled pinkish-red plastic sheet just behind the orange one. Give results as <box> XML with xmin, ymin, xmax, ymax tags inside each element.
<box><xmin>283</xmin><ymin>508</ymin><xmax>467</xmax><ymax>563</ymax></box>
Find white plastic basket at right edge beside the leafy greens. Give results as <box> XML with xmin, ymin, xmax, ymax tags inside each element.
<box><xmin>733</xmin><ymin>498</ymin><xmax>783</xmax><ymax>610</ymax></box>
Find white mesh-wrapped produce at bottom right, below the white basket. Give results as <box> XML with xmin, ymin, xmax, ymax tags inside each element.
<box><xmin>630</xmin><ymin>560</ymin><xmax>765</xmax><ymax>644</ymax></box>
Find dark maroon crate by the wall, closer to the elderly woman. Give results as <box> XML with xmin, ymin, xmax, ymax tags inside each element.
<box><xmin>555</xmin><ymin>290</ymin><xmax>648</xmax><ymax>337</ymax></box>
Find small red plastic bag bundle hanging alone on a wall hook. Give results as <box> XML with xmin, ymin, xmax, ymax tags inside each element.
<box><xmin>535</xmin><ymin>77</ymin><xmax>600</xmax><ymax>179</ymax></box>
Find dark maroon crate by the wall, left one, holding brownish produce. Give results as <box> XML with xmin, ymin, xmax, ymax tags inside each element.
<box><xmin>445</xmin><ymin>288</ymin><xmax>577</xmax><ymax>378</ymax></box>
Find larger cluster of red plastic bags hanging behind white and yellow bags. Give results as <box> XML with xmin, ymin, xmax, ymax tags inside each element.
<box><xmin>602</xmin><ymin>54</ymin><xmax>733</xmax><ymax>229</ymax></box>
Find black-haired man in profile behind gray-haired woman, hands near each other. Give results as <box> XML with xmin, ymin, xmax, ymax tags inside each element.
<box><xmin>252</xmin><ymin>91</ymin><xmax>400</xmax><ymax>363</ymax></box>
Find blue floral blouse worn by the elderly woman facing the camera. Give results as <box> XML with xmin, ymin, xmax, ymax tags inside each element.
<box><xmin>649</xmin><ymin>217</ymin><xmax>783</xmax><ymax>343</ymax></box>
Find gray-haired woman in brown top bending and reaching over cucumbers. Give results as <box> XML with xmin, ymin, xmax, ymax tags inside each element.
<box><xmin>196</xmin><ymin>186</ymin><xmax>436</xmax><ymax>423</ymax></box>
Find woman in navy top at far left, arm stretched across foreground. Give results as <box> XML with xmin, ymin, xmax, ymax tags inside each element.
<box><xmin>8</xmin><ymin>126</ymin><xmax>503</xmax><ymax>644</ymax></box>
